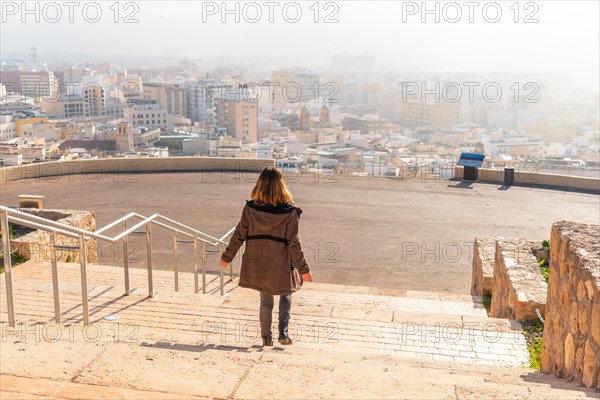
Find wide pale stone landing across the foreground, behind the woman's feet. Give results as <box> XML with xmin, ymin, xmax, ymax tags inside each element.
<box><xmin>0</xmin><ymin>331</ymin><xmax>593</xmax><ymax>399</ymax></box>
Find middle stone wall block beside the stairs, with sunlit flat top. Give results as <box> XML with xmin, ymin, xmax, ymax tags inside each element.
<box><xmin>490</xmin><ymin>238</ymin><xmax>548</xmax><ymax>320</ymax></box>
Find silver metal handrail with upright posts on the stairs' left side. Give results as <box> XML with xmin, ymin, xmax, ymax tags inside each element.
<box><xmin>0</xmin><ymin>206</ymin><xmax>235</xmax><ymax>327</ymax></box>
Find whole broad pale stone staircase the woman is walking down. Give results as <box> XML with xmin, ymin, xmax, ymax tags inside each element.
<box><xmin>0</xmin><ymin>262</ymin><xmax>599</xmax><ymax>399</ymax></box>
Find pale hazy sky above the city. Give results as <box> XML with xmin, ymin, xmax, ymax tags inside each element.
<box><xmin>0</xmin><ymin>0</ymin><xmax>600</xmax><ymax>82</ymax></box>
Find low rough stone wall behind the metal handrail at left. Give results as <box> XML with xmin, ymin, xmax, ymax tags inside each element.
<box><xmin>11</xmin><ymin>208</ymin><xmax>98</xmax><ymax>263</ymax></box>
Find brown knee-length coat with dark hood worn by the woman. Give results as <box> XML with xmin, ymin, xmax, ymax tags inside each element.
<box><xmin>221</xmin><ymin>200</ymin><xmax>310</xmax><ymax>294</ymax></box>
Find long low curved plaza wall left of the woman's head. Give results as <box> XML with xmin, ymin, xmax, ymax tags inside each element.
<box><xmin>0</xmin><ymin>157</ymin><xmax>275</xmax><ymax>183</ymax></box>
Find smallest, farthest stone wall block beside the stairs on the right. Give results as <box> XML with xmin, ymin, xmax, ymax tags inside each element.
<box><xmin>471</xmin><ymin>238</ymin><xmax>496</xmax><ymax>296</ymax></box>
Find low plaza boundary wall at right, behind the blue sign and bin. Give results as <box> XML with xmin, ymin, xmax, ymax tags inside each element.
<box><xmin>454</xmin><ymin>166</ymin><xmax>600</xmax><ymax>194</ymax></box>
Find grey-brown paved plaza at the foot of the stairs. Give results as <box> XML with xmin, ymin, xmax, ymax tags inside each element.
<box><xmin>0</xmin><ymin>173</ymin><xmax>600</xmax><ymax>294</ymax></box>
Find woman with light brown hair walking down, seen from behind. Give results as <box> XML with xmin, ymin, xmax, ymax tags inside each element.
<box><xmin>221</xmin><ymin>167</ymin><xmax>312</xmax><ymax>346</ymax></box>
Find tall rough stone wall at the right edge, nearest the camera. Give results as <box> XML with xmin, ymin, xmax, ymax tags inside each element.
<box><xmin>541</xmin><ymin>221</ymin><xmax>600</xmax><ymax>389</ymax></box>
